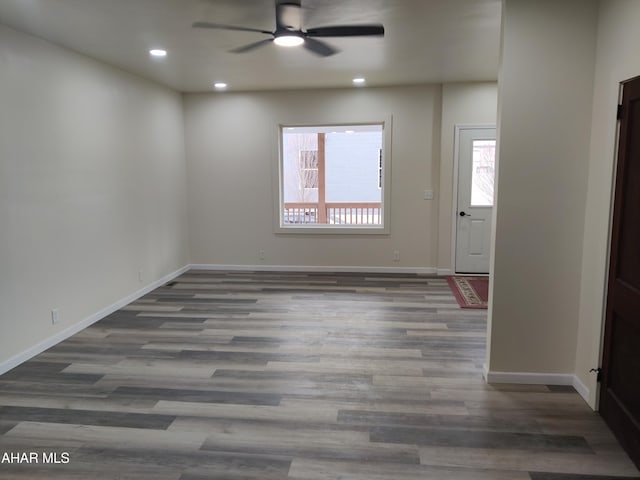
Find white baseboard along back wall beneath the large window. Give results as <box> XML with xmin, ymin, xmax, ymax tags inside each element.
<box><xmin>189</xmin><ymin>263</ymin><xmax>437</xmax><ymax>275</ymax></box>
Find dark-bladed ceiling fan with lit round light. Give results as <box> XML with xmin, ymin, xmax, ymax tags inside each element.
<box><xmin>192</xmin><ymin>0</ymin><xmax>384</xmax><ymax>57</ymax></box>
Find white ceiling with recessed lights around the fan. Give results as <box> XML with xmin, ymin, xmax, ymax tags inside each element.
<box><xmin>0</xmin><ymin>0</ymin><xmax>501</xmax><ymax>92</ymax></box>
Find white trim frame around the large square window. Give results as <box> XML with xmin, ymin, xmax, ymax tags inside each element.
<box><xmin>272</xmin><ymin>115</ymin><xmax>392</xmax><ymax>235</ymax></box>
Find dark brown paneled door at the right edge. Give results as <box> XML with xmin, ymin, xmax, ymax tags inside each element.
<box><xmin>600</xmin><ymin>77</ymin><xmax>640</xmax><ymax>466</ymax></box>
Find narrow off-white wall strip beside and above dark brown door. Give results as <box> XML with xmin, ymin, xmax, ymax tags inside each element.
<box><xmin>575</xmin><ymin>0</ymin><xmax>640</xmax><ymax>406</ymax></box>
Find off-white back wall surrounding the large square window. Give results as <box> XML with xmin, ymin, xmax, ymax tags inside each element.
<box><xmin>185</xmin><ymin>86</ymin><xmax>441</xmax><ymax>269</ymax></box>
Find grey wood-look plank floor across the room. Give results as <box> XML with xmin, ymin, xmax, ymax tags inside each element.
<box><xmin>0</xmin><ymin>271</ymin><xmax>638</xmax><ymax>480</ymax></box>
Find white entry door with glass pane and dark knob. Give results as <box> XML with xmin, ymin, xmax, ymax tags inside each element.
<box><xmin>455</xmin><ymin>127</ymin><xmax>496</xmax><ymax>273</ymax></box>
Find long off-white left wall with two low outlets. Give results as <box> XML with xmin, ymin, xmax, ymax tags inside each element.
<box><xmin>0</xmin><ymin>25</ymin><xmax>188</xmax><ymax>365</ymax></box>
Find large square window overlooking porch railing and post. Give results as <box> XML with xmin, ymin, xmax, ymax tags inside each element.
<box><xmin>277</xmin><ymin>123</ymin><xmax>389</xmax><ymax>233</ymax></box>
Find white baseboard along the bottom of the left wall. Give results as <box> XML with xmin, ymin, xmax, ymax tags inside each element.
<box><xmin>0</xmin><ymin>265</ymin><xmax>189</xmax><ymax>375</ymax></box>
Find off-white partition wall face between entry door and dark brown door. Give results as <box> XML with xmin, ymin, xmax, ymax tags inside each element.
<box><xmin>488</xmin><ymin>0</ymin><xmax>597</xmax><ymax>376</ymax></box>
